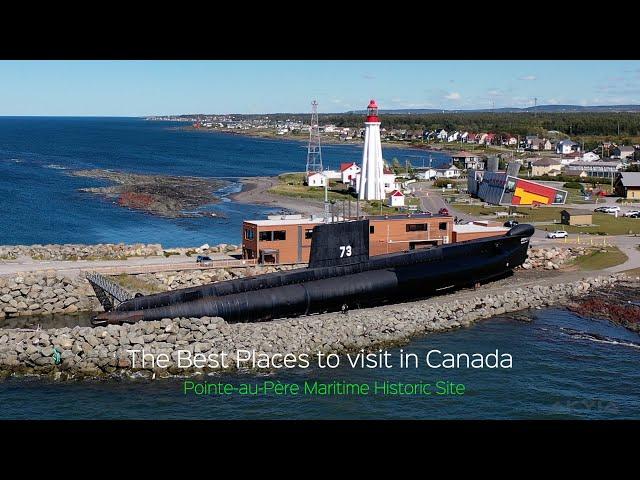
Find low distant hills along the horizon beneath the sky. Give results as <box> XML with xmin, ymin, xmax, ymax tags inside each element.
<box><xmin>345</xmin><ymin>105</ymin><xmax>640</xmax><ymax>115</ymax></box>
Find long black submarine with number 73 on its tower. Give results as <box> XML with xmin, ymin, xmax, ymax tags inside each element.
<box><xmin>92</xmin><ymin>219</ymin><xmax>535</xmax><ymax>325</ymax></box>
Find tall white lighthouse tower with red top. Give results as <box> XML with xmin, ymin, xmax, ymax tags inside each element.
<box><xmin>358</xmin><ymin>100</ymin><xmax>384</xmax><ymax>200</ymax></box>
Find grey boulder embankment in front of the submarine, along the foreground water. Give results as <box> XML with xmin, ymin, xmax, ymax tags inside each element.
<box><xmin>0</xmin><ymin>275</ymin><xmax>624</xmax><ymax>380</ymax></box>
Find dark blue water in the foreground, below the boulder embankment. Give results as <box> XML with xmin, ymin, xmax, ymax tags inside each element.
<box><xmin>0</xmin><ymin>309</ymin><xmax>640</xmax><ymax>419</ymax></box>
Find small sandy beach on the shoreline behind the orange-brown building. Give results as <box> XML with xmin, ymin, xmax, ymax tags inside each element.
<box><xmin>229</xmin><ymin>177</ymin><xmax>324</xmax><ymax>215</ymax></box>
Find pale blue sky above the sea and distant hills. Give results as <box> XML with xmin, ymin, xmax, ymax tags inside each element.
<box><xmin>0</xmin><ymin>60</ymin><xmax>640</xmax><ymax>116</ymax></box>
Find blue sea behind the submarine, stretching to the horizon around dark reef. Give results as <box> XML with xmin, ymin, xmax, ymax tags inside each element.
<box><xmin>0</xmin><ymin>117</ymin><xmax>448</xmax><ymax>247</ymax></box>
